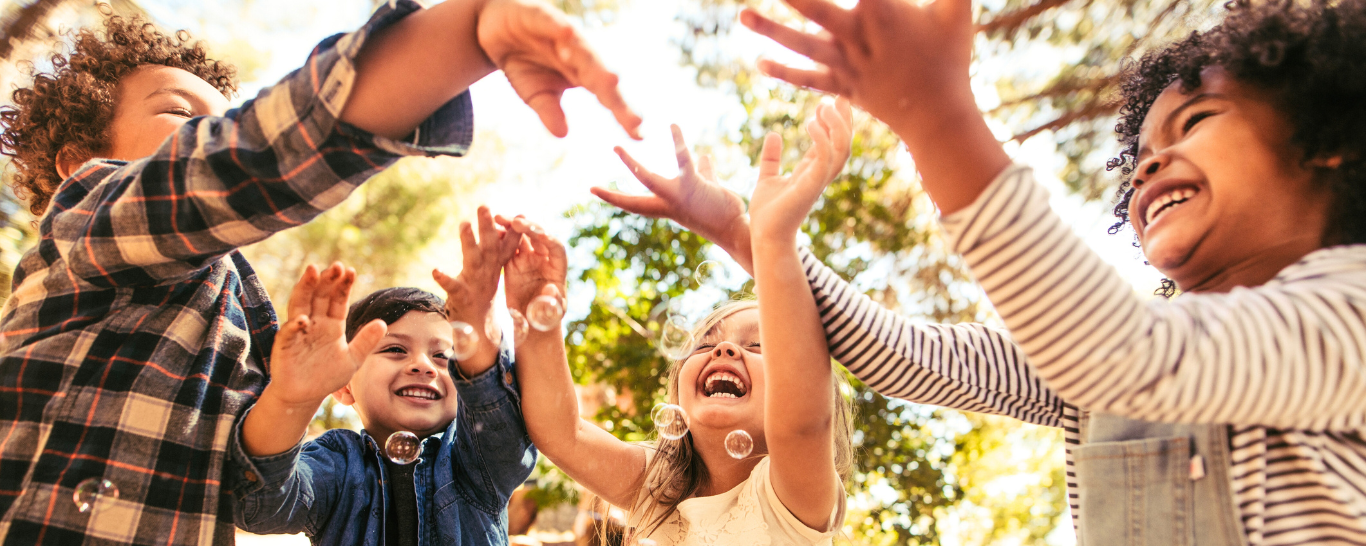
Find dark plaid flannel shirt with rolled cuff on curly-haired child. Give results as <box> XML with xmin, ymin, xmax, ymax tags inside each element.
<box><xmin>0</xmin><ymin>0</ymin><xmax>473</xmax><ymax>545</ymax></box>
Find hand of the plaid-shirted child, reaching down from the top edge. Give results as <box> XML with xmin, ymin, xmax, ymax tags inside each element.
<box><xmin>477</xmin><ymin>0</ymin><xmax>641</xmax><ymax>139</ymax></box>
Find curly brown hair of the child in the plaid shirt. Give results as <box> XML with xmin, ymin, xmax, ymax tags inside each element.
<box><xmin>0</xmin><ymin>14</ymin><xmax>238</xmax><ymax>216</ymax></box>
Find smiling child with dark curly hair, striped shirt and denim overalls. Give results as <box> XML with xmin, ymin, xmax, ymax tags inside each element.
<box><xmin>603</xmin><ymin>0</ymin><xmax>1366</xmax><ymax>545</ymax></box>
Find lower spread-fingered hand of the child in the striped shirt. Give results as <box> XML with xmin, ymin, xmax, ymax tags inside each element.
<box><xmin>591</xmin><ymin>126</ymin><xmax>753</xmax><ymax>275</ymax></box>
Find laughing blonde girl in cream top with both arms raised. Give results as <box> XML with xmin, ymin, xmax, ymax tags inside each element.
<box><xmin>491</xmin><ymin>100</ymin><xmax>851</xmax><ymax>546</ymax></box>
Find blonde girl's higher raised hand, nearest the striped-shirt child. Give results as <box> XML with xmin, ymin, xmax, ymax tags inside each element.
<box><xmin>750</xmin><ymin>98</ymin><xmax>852</xmax><ymax>246</ymax></box>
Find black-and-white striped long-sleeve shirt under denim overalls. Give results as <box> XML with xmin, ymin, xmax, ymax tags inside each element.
<box><xmin>803</xmin><ymin>167</ymin><xmax>1366</xmax><ymax>546</ymax></box>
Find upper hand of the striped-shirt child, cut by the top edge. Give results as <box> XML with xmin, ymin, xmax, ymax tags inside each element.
<box><xmin>740</xmin><ymin>0</ymin><xmax>977</xmax><ymax>128</ymax></box>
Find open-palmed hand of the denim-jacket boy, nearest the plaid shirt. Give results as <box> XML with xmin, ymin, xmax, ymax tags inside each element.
<box><xmin>262</xmin><ymin>263</ymin><xmax>388</xmax><ymax>411</ymax></box>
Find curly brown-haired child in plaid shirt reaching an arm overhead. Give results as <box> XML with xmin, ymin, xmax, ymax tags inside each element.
<box><xmin>0</xmin><ymin>0</ymin><xmax>639</xmax><ymax>545</ymax></box>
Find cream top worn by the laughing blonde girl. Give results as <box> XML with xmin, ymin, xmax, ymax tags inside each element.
<box><xmin>632</xmin><ymin>457</ymin><xmax>844</xmax><ymax>546</ymax></box>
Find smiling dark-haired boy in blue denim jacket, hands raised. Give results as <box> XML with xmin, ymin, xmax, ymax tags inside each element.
<box><xmin>226</xmin><ymin>207</ymin><xmax>535</xmax><ymax>545</ymax></box>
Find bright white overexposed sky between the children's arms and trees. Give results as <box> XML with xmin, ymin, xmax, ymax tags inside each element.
<box><xmin>143</xmin><ymin>0</ymin><xmax>1161</xmax><ymax>296</ymax></box>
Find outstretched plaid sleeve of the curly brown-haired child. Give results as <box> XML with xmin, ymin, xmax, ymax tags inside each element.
<box><xmin>41</xmin><ymin>1</ymin><xmax>473</xmax><ymax>287</ymax></box>
